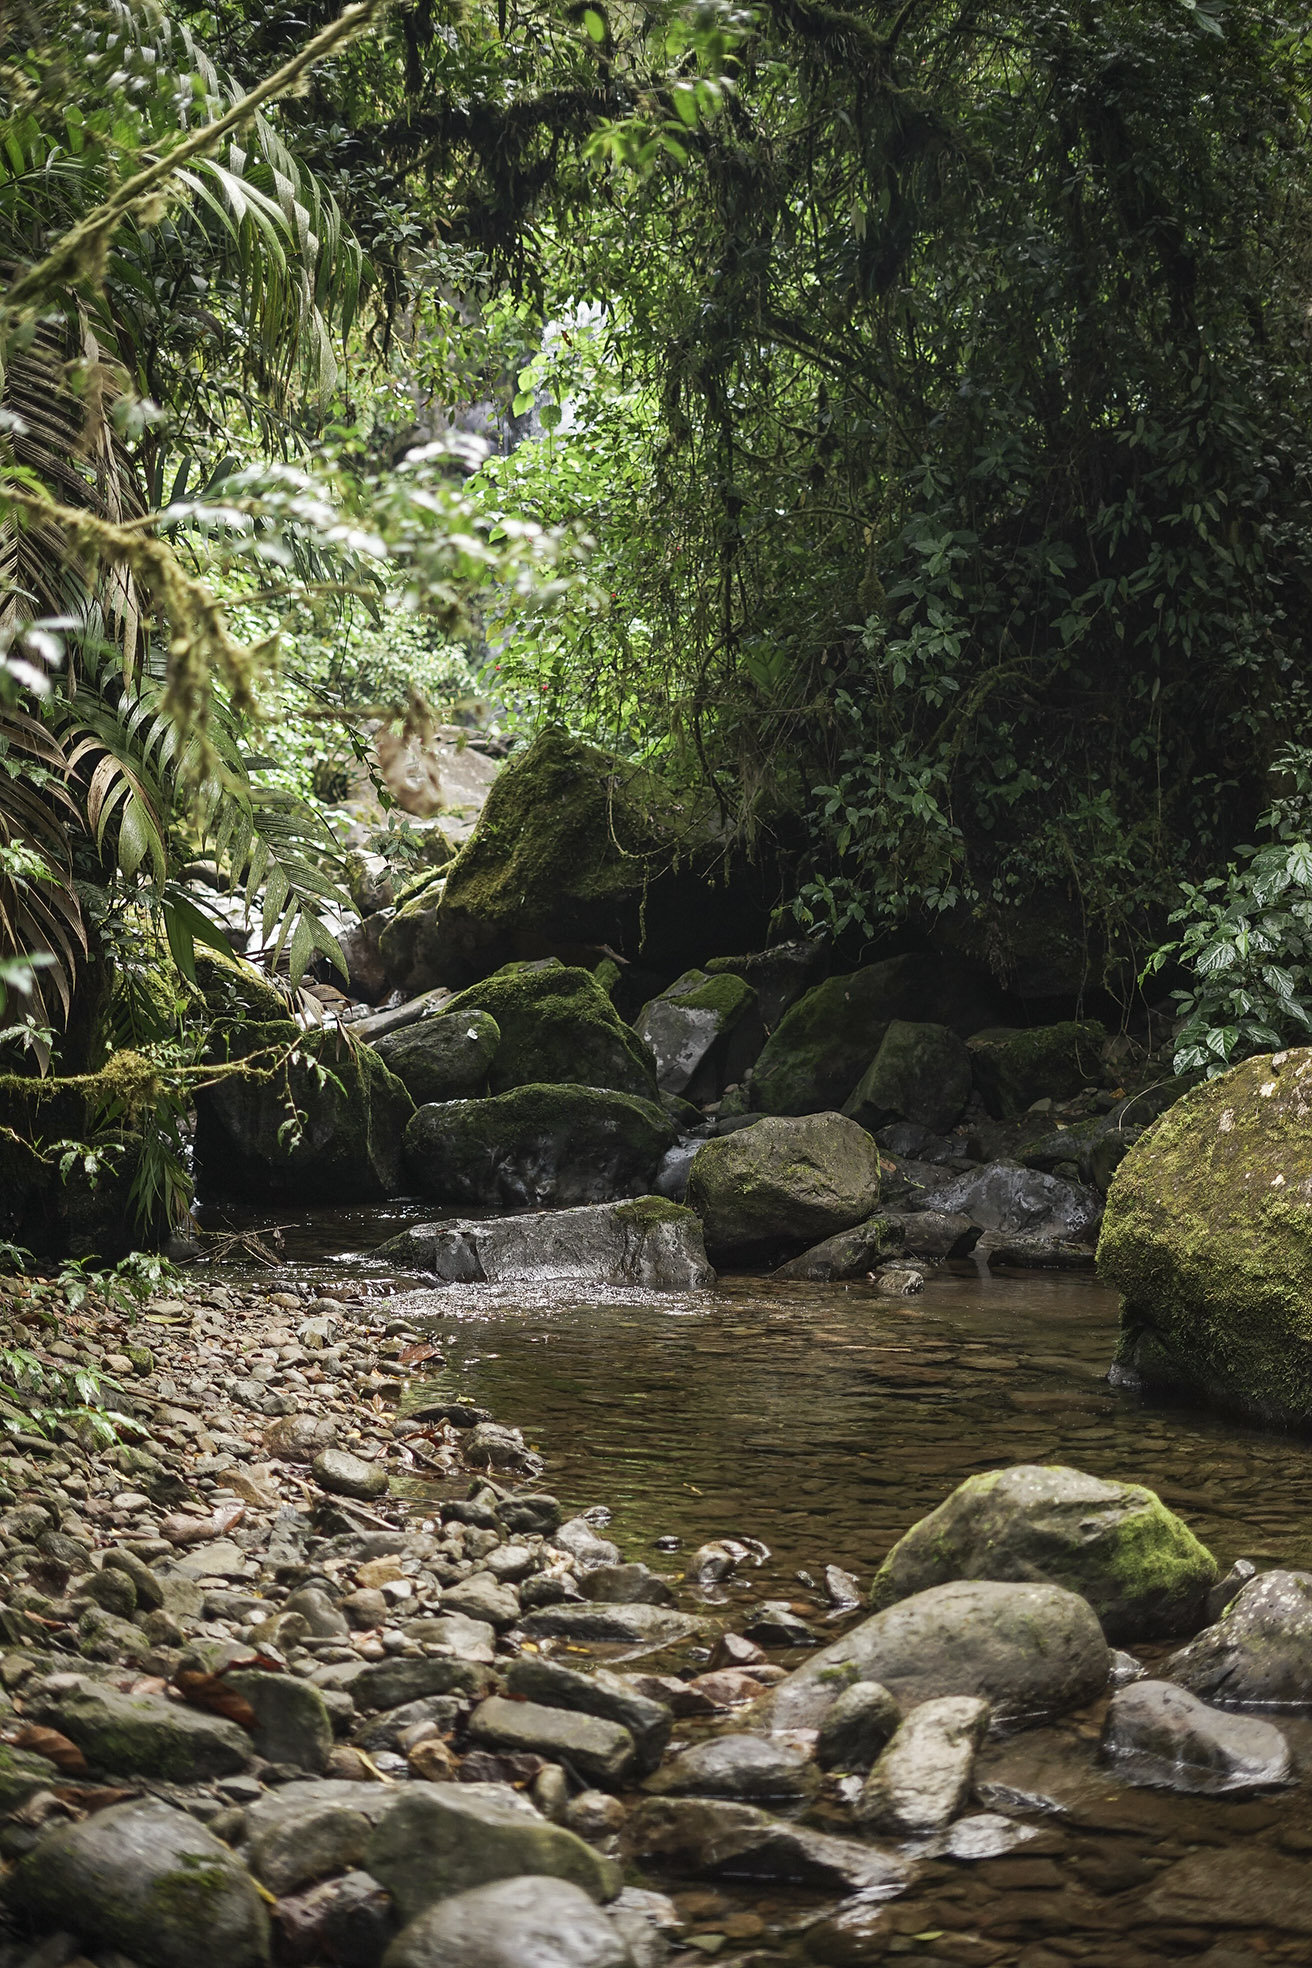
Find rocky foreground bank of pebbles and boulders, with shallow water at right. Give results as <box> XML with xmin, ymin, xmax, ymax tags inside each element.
<box><xmin>0</xmin><ymin>1287</ymin><xmax>1312</xmax><ymax>1968</ymax></box>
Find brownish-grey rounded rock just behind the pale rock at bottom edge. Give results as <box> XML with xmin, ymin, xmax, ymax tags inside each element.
<box><xmin>364</xmin><ymin>1783</ymin><xmax>620</xmax><ymax>1921</ymax></box>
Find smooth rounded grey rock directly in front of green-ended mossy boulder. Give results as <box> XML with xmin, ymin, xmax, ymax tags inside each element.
<box><xmin>755</xmin><ymin>1580</ymin><xmax>1107</xmax><ymax>1730</ymax></box>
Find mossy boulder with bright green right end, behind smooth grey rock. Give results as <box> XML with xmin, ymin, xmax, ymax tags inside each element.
<box><xmin>869</xmin><ymin>1462</ymin><xmax>1218</xmax><ymax>1641</ymax></box>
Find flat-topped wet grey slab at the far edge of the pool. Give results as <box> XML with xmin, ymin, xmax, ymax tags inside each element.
<box><xmin>376</xmin><ymin>1197</ymin><xmax>716</xmax><ymax>1291</ymax></box>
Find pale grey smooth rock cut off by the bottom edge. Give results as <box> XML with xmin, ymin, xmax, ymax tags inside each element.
<box><xmin>384</xmin><ymin>1877</ymin><xmax>635</xmax><ymax>1968</ymax></box>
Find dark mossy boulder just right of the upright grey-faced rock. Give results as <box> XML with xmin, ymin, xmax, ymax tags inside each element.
<box><xmin>753</xmin><ymin>954</ymin><xmax>991</xmax><ymax>1114</ymax></box>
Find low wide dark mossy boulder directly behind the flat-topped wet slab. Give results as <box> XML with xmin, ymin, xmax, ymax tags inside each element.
<box><xmin>405</xmin><ymin>1086</ymin><xmax>675</xmax><ymax>1210</ymax></box>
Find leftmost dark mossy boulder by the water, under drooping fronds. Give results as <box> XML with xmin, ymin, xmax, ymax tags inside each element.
<box><xmin>197</xmin><ymin>1021</ymin><xmax>415</xmax><ymax>1202</ymax></box>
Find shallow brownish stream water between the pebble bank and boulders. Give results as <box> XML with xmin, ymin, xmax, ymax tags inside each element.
<box><xmin>200</xmin><ymin>1212</ymin><xmax>1312</xmax><ymax>1968</ymax></box>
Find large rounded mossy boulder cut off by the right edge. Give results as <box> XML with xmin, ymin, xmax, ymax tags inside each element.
<box><xmin>1098</xmin><ymin>1047</ymin><xmax>1312</xmax><ymax>1427</ymax></box>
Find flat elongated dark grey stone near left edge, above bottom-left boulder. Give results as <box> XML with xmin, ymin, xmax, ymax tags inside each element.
<box><xmin>26</xmin><ymin>1675</ymin><xmax>252</xmax><ymax>1783</ymax></box>
